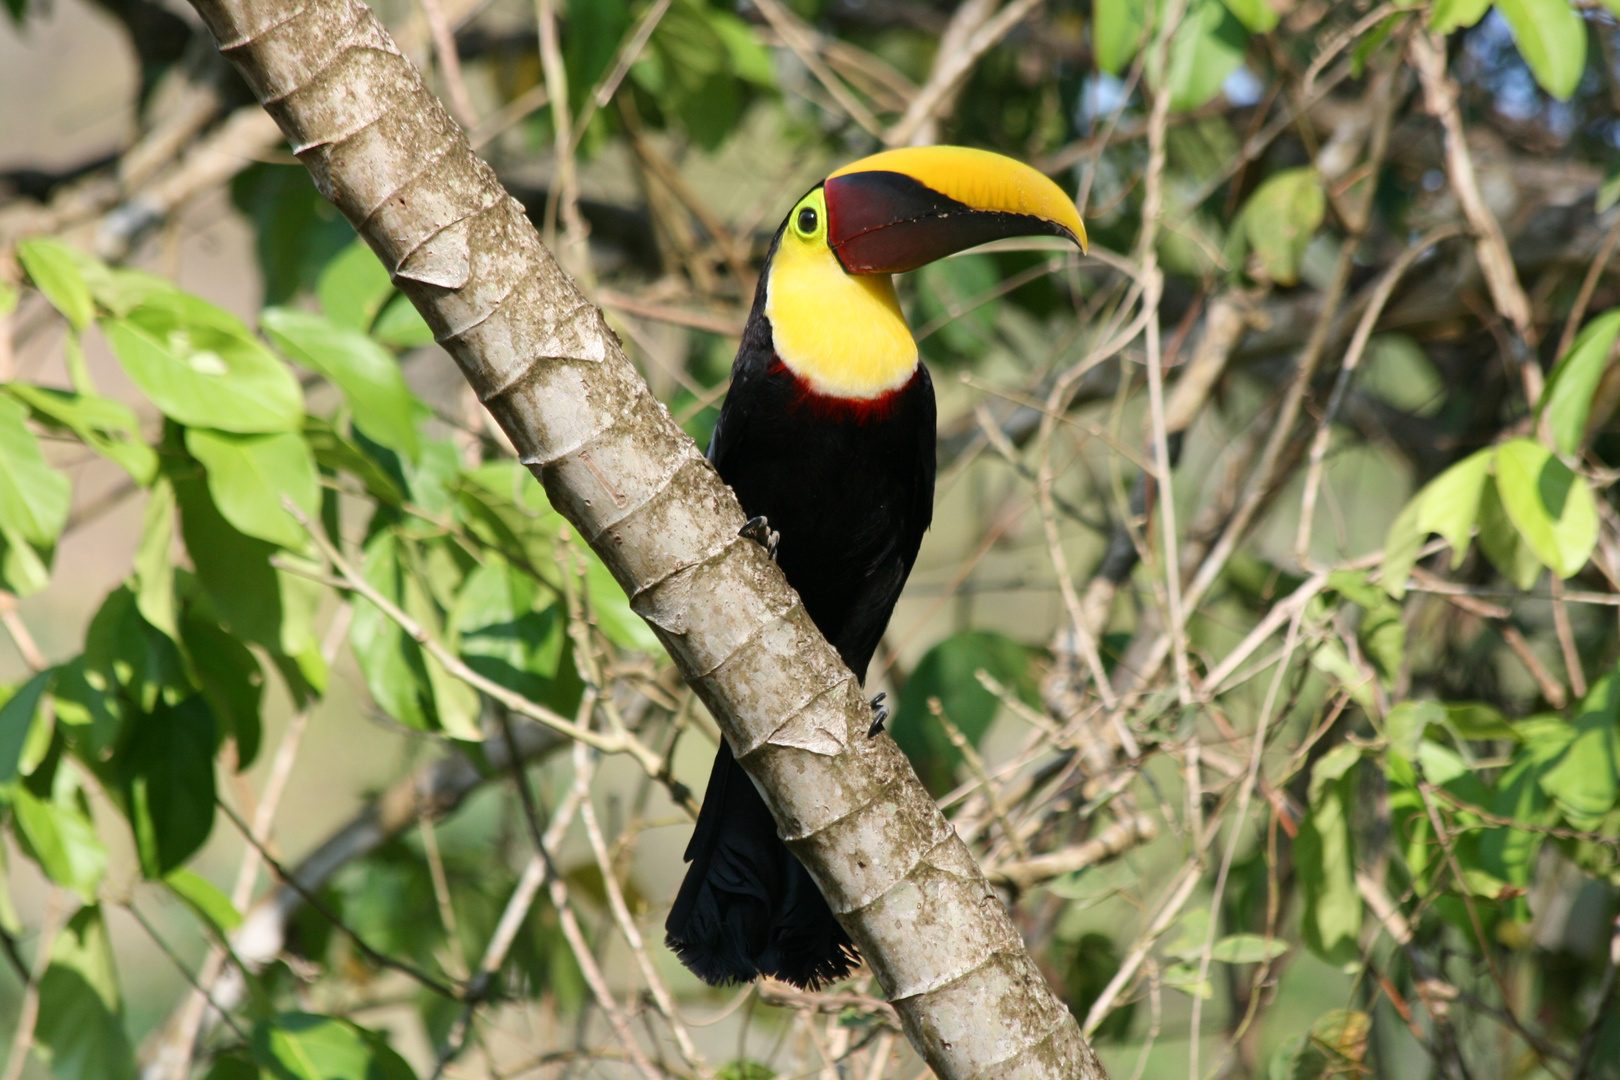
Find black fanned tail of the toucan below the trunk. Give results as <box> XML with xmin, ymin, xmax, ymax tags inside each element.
<box><xmin>664</xmin><ymin>740</ymin><xmax>859</xmax><ymax>989</ymax></box>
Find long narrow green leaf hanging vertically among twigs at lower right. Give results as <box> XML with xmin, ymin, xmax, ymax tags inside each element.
<box><xmin>1294</xmin><ymin>745</ymin><xmax>1361</xmax><ymax>963</ymax></box>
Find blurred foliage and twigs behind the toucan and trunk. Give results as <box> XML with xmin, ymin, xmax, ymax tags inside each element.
<box><xmin>0</xmin><ymin>0</ymin><xmax>1620</xmax><ymax>1080</ymax></box>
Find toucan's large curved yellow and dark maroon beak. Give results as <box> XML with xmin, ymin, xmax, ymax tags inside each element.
<box><xmin>825</xmin><ymin>146</ymin><xmax>1085</xmax><ymax>274</ymax></box>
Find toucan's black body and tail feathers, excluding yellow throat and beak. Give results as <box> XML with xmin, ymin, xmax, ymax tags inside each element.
<box><xmin>666</xmin><ymin>232</ymin><xmax>935</xmax><ymax>988</ymax></box>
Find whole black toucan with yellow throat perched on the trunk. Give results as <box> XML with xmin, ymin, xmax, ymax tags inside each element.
<box><xmin>664</xmin><ymin>146</ymin><xmax>1085</xmax><ymax>989</ymax></box>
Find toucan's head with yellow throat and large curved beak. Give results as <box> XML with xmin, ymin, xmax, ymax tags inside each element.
<box><xmin>761</xmin><ymin>146</ymin><xmax>1085</xmax><ymax>398</ymax></box>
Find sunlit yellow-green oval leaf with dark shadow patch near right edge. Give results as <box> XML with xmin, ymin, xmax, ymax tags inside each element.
<box><xmin>1495</xmin><ymin>439</ymin><xmax>1597</xmax><ymax>578</ymax></box>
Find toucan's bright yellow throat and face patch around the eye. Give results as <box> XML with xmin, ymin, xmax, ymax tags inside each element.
<box><xmin>765</xmin><ymin>188</ymin><xmax>917</xmax><ymax>400</ymax></box>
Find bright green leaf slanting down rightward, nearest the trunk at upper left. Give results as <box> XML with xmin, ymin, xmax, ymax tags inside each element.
<box><xmin>261</xmin><ymin>307</ymin><xmax>426</xmax><ymax>458</ymax></box>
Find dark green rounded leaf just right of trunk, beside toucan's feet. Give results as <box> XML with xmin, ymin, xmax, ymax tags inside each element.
<box><xmin>889</xmin><ymin>631</ymin><xmax>1034</xmax><ymax>793</ymax></box>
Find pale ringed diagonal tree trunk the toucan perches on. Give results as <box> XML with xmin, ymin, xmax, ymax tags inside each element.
<box><xmin>183</xmin><ymin>0</ymin><xmax>1105</xmax><ymax>1080</ymax></box>
